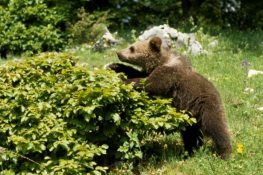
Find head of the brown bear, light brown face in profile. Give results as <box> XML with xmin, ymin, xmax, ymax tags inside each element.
<box><xmin>117</xmin><ymin>37</ymin><xmax>167</xmax><ymax>74</ymax></box>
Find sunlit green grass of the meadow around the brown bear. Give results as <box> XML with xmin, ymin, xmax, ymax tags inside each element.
<box><xmin>72</xmin><ymin>31</ymin><xmax>263</xmax><ymax>175</ymax></box>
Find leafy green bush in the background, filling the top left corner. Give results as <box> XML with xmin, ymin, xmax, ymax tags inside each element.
<box><xmin>0</xmin><ymin>0</ymin><xmax>69</xmax><ymax>57</ymax></box>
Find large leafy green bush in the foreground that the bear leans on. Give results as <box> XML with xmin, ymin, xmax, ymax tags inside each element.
<box><xmin>0</xmin><ymin>53</ymin><xmax>194</xmax><ymax>174</ymax></box>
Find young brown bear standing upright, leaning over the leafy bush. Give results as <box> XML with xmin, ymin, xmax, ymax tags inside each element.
<box><xmin>109</xmin><ymin>37</ymin><xmax>231</xmax><ymax>158</ymax></box>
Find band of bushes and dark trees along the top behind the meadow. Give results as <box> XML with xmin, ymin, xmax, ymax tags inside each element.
<box><xmin>0</xmin><ymin>0</ymin><xmax>263</xmax><ymax>58</ymax></box>
